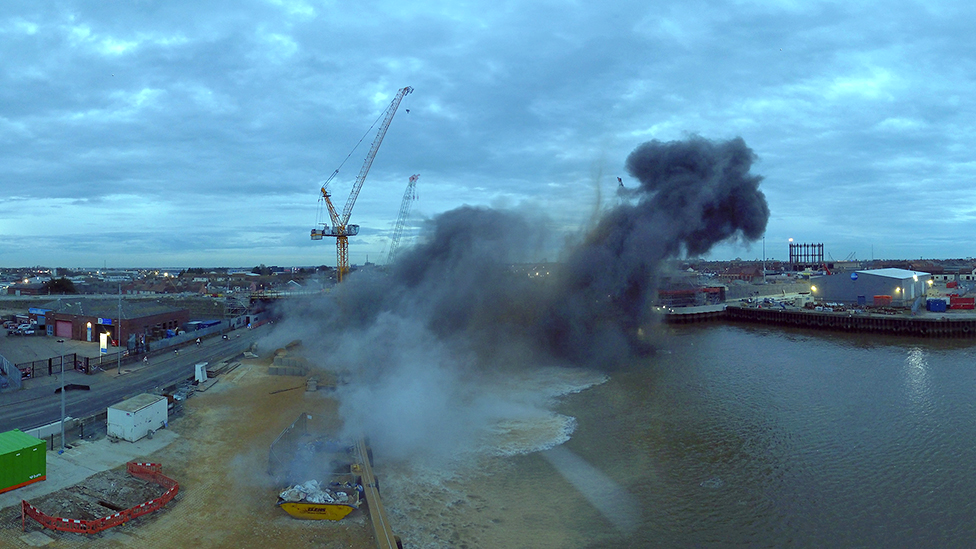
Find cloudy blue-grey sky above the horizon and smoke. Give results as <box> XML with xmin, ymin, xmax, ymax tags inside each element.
<box><xmin>0</xmin><ymin>0</ymin><xmax>976</xmax><ymax>268</ymax></box>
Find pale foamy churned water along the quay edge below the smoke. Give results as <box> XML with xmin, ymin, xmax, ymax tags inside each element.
<box><xmin>377</xmin><ymin>367</ymin><xmax>609</xmax><ymax>547</ymax></box>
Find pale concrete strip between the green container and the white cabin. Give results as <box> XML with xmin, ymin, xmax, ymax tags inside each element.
<box><xmin>0</xmin><ymin>429</ymin><xmax>179</xmax><ymax>509</ymax></box>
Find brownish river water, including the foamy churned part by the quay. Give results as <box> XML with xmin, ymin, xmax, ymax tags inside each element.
<box><xmin>378</xmin><ymin>323</ymin><xmax>976</xmax><ymax>548</ymax></box>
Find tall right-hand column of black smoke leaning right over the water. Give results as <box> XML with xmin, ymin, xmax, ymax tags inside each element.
<box><xmin>542</xmin><ymin>133</ymin><xmax>769</xmax><ymax>365</ymax></box>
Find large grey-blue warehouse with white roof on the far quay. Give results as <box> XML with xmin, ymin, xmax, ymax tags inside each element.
<box><xmin>811</xmin><ymin>269</ymin><xmax>931</xmax><ymax>307</ymax></box>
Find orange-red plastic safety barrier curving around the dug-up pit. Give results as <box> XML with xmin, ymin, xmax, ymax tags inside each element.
<box><xmin>20</xmin><ymin>461</ymin><xmax>180</xmax><ymax>534</ymax></box>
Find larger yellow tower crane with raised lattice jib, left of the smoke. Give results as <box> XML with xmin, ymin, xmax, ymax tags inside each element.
<box><xmin>312</xmin><ymin>86</ymin><xmax>413</xmax><ymax>282</ymax></box>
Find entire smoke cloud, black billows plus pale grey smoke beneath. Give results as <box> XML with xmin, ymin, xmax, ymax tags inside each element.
<box><xmin>268</xmin><ymin>137</ymin><xmax>769</xmax><ymax>458</ymax></box>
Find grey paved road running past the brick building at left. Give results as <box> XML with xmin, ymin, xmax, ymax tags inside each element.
<box><xmin>0</xmin><ymin>326</ymin><xmax>268</xmax><ymax>432</ymax></box>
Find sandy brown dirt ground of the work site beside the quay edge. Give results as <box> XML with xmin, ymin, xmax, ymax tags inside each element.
<box><xmin>0</xmin><ymin>354</ymin><xmax>376</xmax><ymax>548</ymax></box>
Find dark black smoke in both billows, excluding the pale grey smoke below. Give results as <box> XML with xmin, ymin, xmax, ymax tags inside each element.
<box><xmin>304</xmin><ymin>137</ymin><xmax>769</xmax><ymax>367</ymax></box>
